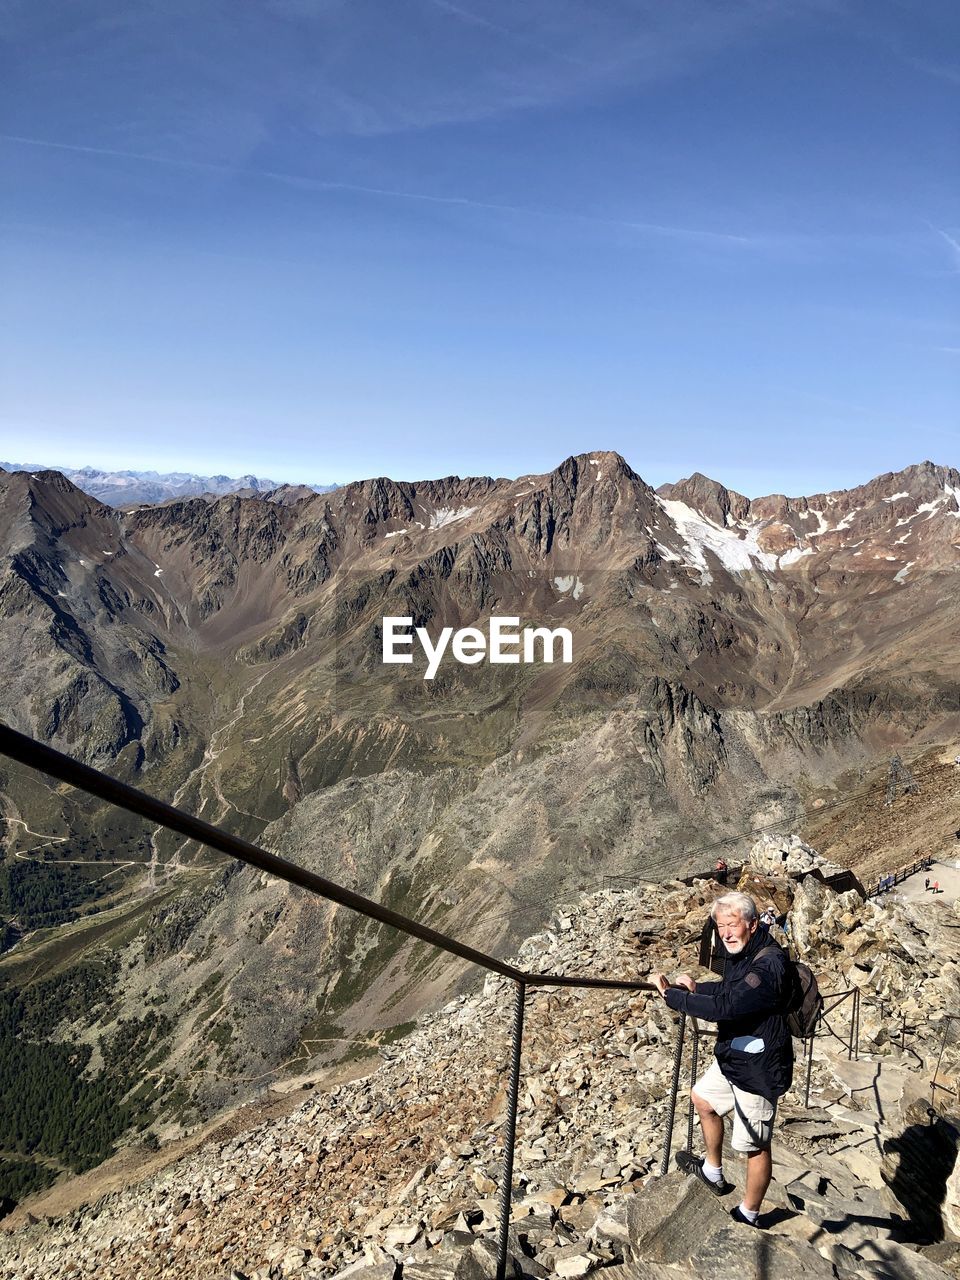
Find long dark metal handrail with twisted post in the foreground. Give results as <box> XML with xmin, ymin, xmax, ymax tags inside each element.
<box><xmin>0</xmin><ymin>724</ymin><xmax>657</xmax><ymax>1280</ymax></box>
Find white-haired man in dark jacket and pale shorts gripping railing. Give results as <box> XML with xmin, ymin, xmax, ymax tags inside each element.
<box><xmin>652</xmin><ymin>893</ymin><xmax>794</xmax><ymax>1226</ymax></box>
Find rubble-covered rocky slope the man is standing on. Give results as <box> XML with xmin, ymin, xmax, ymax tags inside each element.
<box><xmin>0</xmin><ymin>837</ymin><xmax>960</xmax><ymax>1280</ymax></box>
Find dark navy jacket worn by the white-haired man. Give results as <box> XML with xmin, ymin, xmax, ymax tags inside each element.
<box><xmin>666</xmin><ymin>924</ymin><xmax>794</xmax><ymax>1102</ymax></box>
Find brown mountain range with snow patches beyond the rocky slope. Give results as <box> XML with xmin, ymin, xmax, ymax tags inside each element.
<box><xmin>0</xmin><ymin>452</ymin><xmax>960</xmax><ymax>1203</ymax></box>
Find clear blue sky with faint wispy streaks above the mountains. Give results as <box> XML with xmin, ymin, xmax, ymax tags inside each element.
<box><xmin>0</xmin><ymin>0</ymin><xmax>960</xmax><ymax>495</ymax></box>
